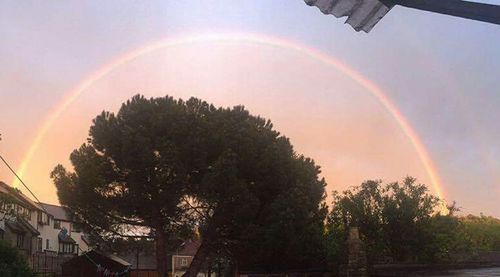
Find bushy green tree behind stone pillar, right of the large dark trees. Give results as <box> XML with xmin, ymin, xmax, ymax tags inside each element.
<box><xmin>327</xmin><ymin>177</ymin><xmax>465</xmax><ymax>263</ymax></box>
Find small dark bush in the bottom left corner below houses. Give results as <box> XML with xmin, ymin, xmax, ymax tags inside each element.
<box><xmin>0</xmin><ymin>240</ymin><xmax>33</xmax><ymax>277</ymax></box>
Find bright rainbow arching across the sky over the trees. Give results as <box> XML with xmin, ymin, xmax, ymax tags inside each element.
<box><xmin>12</xmin><ymin>33</ymin><xmax>444</xmax><ymax>199</ymax></box>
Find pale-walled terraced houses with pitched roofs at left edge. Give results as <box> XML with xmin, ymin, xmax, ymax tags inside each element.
<box><xmin>0</xmin><ymin>182</ymin><xmax>88</xmax><ymax>256</ymax></box>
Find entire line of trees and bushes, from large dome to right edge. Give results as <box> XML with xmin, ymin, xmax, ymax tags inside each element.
<box><xmin>51</xmin><ymin>95</ymin><xmax>499</xmax><ymax>277</ymax></box>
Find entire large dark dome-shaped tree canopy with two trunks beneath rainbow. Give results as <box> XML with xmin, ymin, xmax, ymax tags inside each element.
<box><xmin>52</xmin><ymin>96</ymin><xmax>326</xmax><ymax>276</ymax></box>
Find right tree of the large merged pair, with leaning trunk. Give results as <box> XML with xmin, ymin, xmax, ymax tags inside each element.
<box><xmin>186</xmin><ymin>107</ymin><xmax>327</xmax><ymax>276</ymax></box>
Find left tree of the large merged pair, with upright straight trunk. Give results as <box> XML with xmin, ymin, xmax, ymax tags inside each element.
<box><xmin>52</xmin><ymin>95</ymin><xmax>215</xmax><ymax>276</ymax></box>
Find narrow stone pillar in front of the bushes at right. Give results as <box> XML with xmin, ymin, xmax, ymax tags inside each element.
<box><xmin>345</xmin><ymin>227</ymin><xmax>368</xmax><ymax>277</ymax></box>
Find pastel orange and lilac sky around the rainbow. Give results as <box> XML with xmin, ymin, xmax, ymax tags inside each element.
<box><xmin>0</xmin><ymin>0</ymin><xmax>500</xmax><ymax>217</ymax></box>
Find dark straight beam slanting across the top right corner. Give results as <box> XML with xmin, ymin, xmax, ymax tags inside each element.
<box><xmin>380</xmin><ymin>0</ymin><xmax>500</xmax><ymax>25</ymax></box>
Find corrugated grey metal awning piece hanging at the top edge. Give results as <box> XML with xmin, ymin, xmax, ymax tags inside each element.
<box><xmin>304</xmin><ymin>0</ymin><xmax>393</xmax><ymax>33</ymax></box>
